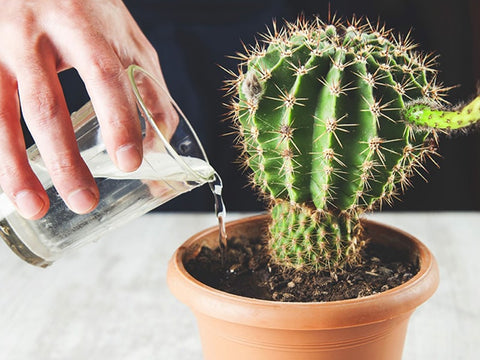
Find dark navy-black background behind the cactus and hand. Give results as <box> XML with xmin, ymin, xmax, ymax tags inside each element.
<box><xmin>25</xmin><ymin>0</ymin><xmax>480</xmax><ymax>211</ymax></box>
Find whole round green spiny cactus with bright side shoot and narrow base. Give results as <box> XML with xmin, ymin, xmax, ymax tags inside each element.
<box><xmin>227</xmin><ymin>19</ymin><xmax>480</xmax><ymax>272</ymax></box>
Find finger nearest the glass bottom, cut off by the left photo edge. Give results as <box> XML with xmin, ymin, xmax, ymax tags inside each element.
<box><xmin>0</xmin><ymin>68</ymin><xmax>49</xmax><ymax>220</ymax></box>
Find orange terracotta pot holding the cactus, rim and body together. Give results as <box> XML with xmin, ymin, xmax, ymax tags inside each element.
<box><xmin>167</xmin><ymin>216</ymin><xmax>439</xmax><ymax>360</ymax></box>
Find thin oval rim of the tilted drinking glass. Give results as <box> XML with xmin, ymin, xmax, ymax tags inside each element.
<box><xmin>127</xmin><ymin>64</ymin><xmax>211</xmax><ymax>182</ymax></box>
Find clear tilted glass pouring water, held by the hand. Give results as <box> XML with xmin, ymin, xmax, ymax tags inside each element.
<box><xmin>0</xmin><ymin>65</ymin><xmax>215</xmax><ymax>267</ymax></box>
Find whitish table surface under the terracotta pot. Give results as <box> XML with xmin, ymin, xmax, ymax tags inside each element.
<box><xmin>0</xmin><ymin>212</ymin><xmax>480</xmax><ymax>360</ymax></box>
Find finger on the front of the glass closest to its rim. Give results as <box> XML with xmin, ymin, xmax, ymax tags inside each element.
<box><xmin>72</xmin><ymin>38</ymin><xmax>143</xmax><ymax>172</ymax></box>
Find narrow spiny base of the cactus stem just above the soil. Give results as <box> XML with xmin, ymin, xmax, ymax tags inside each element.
<box><xmin>269</xmin><ymin>201</ymin><xmax>365</xmax><ymax>273</ymax></box>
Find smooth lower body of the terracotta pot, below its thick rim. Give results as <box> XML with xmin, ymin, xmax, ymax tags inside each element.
<box><xmin>197</xmin><ymin>313</ymin><xmax>410</xmax><ymax>360</ymax></box>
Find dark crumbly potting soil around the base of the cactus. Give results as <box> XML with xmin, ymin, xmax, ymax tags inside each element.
<box><xmin>185</xmin><ymin>238</ymin><xmax>418</xmax><ymax>302</ymax></box>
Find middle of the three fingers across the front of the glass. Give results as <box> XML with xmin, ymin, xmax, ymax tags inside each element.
<box><xmin>16</xmin><ymin>57</ymin><xmax>99</xmax><ymax>214</ymax></box>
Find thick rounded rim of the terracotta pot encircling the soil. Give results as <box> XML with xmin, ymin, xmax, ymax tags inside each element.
<box><xmin>167</xmin><ymin>214</ymin><xmax>439</xmax><ymax>329</ymax></box>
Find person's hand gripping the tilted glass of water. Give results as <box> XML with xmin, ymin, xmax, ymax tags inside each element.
<box><xmin>0</xmin><ymin>0</ymin><xmax>176</xmax><ymax>219</ymax></box>
